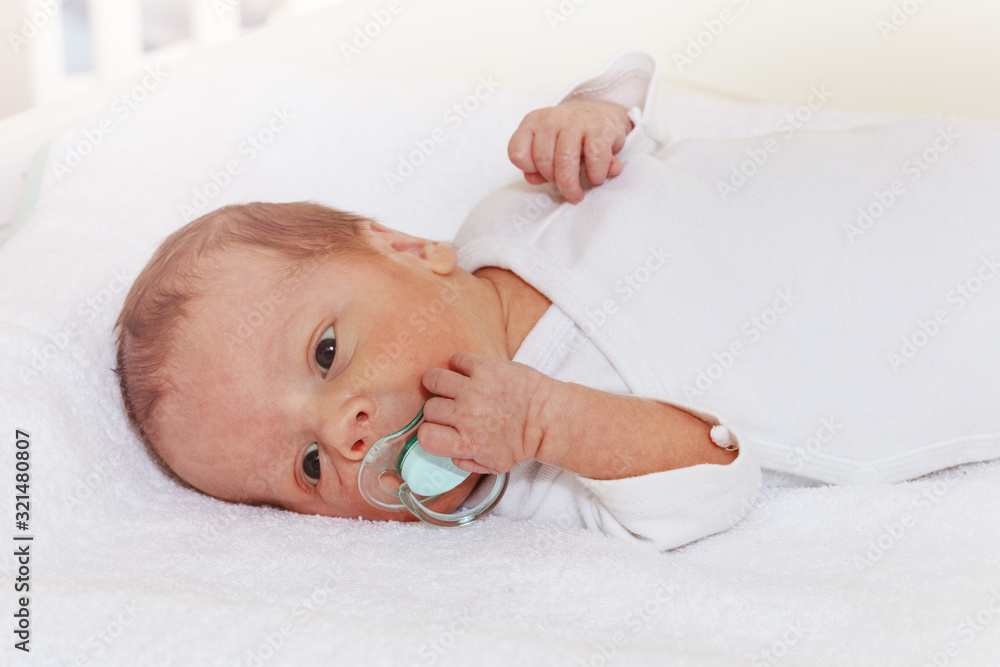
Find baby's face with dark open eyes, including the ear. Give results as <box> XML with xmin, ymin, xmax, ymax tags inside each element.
<box><xmin>158</xmin><ymin>228</ymin><xmax>494</xmax><ymax>520</ymax></box>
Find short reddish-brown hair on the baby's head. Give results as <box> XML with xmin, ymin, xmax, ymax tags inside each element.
<box><xmin>114</xmin><ymin>203</ymin><xmax>379</xmax><ymax>468</ymax></box>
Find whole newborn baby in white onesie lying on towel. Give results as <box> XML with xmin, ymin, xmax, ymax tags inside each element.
<box><xmin>117</xmin><ymin>52</ymin><xmax>1000</xmax><ymax>549</ymax></box>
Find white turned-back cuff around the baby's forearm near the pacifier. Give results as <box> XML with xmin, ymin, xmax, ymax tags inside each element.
<box><xmin>575</xmin><ymin>395</ymin><xmax>761</xmax><ymax>551</ymax></box>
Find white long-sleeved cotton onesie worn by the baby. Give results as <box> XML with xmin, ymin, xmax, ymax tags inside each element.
<box><xmin>454</xmin><ymin>51</ymin><xmax>1000</xmax><ymax>549</ymax></box>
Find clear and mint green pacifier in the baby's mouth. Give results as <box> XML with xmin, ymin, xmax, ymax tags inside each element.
<box><xmin>358</xmin><ymin>406</ymin><xmax>507</xmax><ymax>527</ymax></box>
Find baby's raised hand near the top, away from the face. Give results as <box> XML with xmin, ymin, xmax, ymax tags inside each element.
<box><xmin>507</xmin><ymin>100</ymin><xmax>632</xmax><ymax>204</ymax></box>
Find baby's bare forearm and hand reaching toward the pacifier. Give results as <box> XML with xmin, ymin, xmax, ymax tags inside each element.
<box><xmin>419</xmin><ymin>352</ymin><xmax>736</xmax><ymax>480</ymax></box>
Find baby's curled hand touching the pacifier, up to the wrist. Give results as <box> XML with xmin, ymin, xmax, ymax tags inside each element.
<box><xmin>417</xmin><ymin>352</ymin><xmax>554</xmax><ymax>474</ymax></box>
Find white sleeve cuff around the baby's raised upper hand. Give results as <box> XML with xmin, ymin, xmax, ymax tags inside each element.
<box><xmin>553</xmin><ymin>50</ymin><xmax>670</xmax><ymax>160</ymax></box>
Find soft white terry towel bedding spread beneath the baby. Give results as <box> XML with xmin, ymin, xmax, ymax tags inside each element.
<box><xmin>0</xmin><ymin>64</ymin><xmax>1000</xmax><ymax>667</ymax></box>
